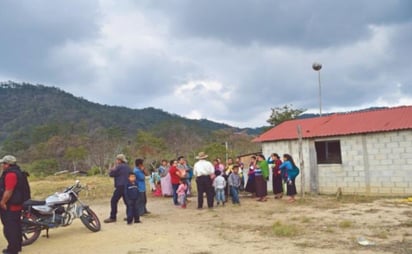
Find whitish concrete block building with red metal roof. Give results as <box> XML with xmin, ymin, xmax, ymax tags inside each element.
<box><xmin>254</xmin><ymin>106</ymin><xmax>412</xmax><ymax>195</ymax></box>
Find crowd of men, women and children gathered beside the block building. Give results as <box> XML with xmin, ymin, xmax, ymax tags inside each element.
<box><xmin>151</xmin><ymin>152</ymin><xmax>298</xmax><ymax>209</ymax></box>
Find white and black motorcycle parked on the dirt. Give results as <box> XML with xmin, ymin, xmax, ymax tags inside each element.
<box><xmin>21</xmin><ymin>180</ymin><xmax>101</xmax><ymax>246</ymax></box>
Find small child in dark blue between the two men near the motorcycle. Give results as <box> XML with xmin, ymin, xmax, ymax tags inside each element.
<box><xmin>124</xmin><ymin>172</ymin><xmax>140</xmax><ymax>225</ymax></box>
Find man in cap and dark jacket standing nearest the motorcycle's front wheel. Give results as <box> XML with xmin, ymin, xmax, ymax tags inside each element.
<box><xmin>104</xmin><ymin>154</ymin><xmax>132</xmax><ymax>223</ymax></box>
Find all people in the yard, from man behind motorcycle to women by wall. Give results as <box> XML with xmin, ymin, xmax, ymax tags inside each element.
<box><xmin>0</xmin><ymin>152</ymin><xmax>299</xmax><ymax>253</ymax></box>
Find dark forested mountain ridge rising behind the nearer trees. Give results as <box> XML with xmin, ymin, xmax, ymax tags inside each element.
<box><xmin>0</xmin><ymin>81</ymin><xmax>261</xmax><ymax>146</ymax></box>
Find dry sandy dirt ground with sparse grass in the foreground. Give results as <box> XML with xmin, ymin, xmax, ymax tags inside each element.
<box><xmin>0</xmin><ymin>193</ymin><xmax>412</xmax><ymax>254</ymax></box>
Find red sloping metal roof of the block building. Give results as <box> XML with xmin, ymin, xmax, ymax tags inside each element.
<box><xmin>253</xmin><ymin>106</ymin><xmax>412</xmax><ymax>142</ymax></box>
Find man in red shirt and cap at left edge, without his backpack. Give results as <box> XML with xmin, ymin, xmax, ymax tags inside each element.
<box><xmin>0</xmin><ymin>155</ymin><xmax>23</xmax><ymax>254</ymax></box>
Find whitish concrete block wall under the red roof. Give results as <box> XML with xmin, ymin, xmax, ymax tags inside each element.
<box><xmin>262</xmin><ymin>130</ymin><xmax>412</xmax><ymax>196</ymax></box>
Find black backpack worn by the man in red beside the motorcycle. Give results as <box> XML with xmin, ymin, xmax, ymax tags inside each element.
<box><xmin>1</xmin><ymin>167</ymin><xmax>31</xmax><ymax>205</ymax></box>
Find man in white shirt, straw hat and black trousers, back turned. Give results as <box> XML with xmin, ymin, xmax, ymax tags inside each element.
<box><xmin>193</xmin><ymin>152</ymin><xmax>215</xmax><ymax>209</ymax></box>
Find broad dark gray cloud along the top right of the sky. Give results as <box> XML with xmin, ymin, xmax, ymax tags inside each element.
<box><xmin>152</xmin><ymin>0</ymin><xmax>412</xmax><ymax>48</ymax></box>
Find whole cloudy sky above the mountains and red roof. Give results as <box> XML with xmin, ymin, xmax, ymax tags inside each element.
<box><xmin>0</xmin><ymin>0</ymin><xmax>412</xmax><ymax>127</ymax></box>
